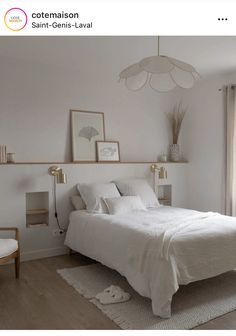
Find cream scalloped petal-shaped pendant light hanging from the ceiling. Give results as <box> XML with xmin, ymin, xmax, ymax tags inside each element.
<box><xmin>120</xmin><ymin>36</ymin><xmax>200</xmax><ymax>92</ymax></box>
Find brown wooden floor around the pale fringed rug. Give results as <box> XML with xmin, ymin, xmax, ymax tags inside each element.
<box><xmin>0</xmin><ymin>254</ymin><xmax>236</xmax><ymax>330</ymax></box>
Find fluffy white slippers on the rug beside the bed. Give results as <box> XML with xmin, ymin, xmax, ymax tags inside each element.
<box><xmin>95</xmin><ymin>285</ymin><xmax>130</xmax><ymax>304</ymax></box>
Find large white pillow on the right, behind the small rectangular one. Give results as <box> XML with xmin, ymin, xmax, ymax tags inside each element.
<box><xmin>115</xmin><ymin>179</ymin><xmax>160</xmax><ymax>208</ymax></box>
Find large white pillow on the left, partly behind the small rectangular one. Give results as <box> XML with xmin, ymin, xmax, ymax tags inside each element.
<box><xmin>77</xmin><ymin>183</ymin><xmax>121</xmax><ymax>213</ymax></box>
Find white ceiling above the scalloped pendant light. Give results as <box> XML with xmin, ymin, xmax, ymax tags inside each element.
<box><xmin>0</xmin><ymin>36</ymin><xmax>236</xmax><ymax>77</ymax></box>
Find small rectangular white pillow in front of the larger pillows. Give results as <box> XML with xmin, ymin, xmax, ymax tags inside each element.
<box><xmin>103</xmin><ymin>196</ymin><xmax>147</xmax><ymax>215</ymax></box>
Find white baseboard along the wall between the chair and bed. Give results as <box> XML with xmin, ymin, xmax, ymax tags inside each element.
<box><xmin>21</xmin><ymin>246</ymin><xmax>69</xmax><ymax>261</ymax></box>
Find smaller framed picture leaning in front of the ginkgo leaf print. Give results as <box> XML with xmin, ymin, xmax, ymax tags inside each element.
<box><xmin>96</xmin><ymin>141</ymin><xmax>120</xmax><ymax>162</ymax></box>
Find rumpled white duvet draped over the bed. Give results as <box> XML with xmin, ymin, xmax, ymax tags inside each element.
<box><xmin>65</xmin><ymin>206</ymin><xmax>236</xmax><ymax>317</ymax></box>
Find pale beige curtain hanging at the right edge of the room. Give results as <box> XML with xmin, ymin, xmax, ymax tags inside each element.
<box><xmin>225</xmin><ymin>85</ymin><xmax>236</xmax><ymax>216</ymax></box>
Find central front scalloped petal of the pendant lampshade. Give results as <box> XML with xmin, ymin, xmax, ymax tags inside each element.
<box><xmin>149</xmin><ymin>73</ymin><xmax>176</xmax><ymax>92</ymax></box>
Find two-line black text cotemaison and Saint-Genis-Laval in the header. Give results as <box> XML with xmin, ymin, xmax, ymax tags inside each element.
<box><xmin>32</xmin><ymin>11</ymin><xmax>93</xmax><ymax>28</ymax></box>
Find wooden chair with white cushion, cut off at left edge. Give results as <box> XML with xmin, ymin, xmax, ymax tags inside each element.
<box><xmin>0</xmin><ymin>227</ymin><xmax>20</xmax><ymax>278</ymax></box>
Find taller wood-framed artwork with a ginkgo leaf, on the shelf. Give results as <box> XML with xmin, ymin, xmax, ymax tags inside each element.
<box><xmin>70</xmin><ymin>110</ymin><xmax>105</xmax><ymax>162</ymax></box>
